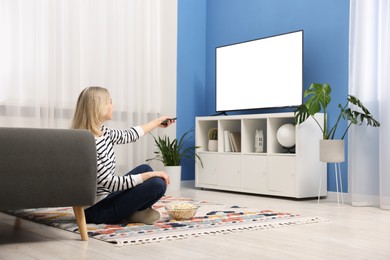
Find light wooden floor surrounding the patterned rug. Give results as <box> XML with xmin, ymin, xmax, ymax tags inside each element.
<box><xmin>0</xmin><ymin>182</ymin><xmax>390</xmax><ymax>260</ymax></box>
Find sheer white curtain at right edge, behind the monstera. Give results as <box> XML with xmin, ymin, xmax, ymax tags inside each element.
<box><xmin>348</xmin><ymin>0</ymin><xmax>390</xmax><ymax>209</ymax></box>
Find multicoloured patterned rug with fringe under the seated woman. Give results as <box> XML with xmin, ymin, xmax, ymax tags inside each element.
<box><xmin>6</xmin><ymin>196</ymin><xmax>326</xmax><ymax>246</ymax></box>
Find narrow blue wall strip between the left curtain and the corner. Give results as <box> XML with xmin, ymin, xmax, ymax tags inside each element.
<box><xmin>176</xmin><ymin>0</ymin><xmax>207</xmax><ymax>180</ymax></box>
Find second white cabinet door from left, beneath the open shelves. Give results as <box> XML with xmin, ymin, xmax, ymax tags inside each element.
<box><xmin>218</xmin><ymin>154</ymin><xmax>241</xmax><ymax>188</ymax></box>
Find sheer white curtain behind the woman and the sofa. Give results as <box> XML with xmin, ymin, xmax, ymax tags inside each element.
<box><xmin>0</xmin><ymin>0</ymin><xmax>177</xmax><ymax>174</ymax></box>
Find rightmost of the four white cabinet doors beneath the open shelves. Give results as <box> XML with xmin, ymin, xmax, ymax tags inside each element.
<box><xmin>267</xmin><ymin>155</ymin><xmax>296</xmax><ymax>196</ymax></box>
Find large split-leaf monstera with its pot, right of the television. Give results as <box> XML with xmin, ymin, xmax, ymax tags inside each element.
<box><xmin>294</xmin><ymin>83</ymin><xmax>380</xmax><ymax>162</ymax></box>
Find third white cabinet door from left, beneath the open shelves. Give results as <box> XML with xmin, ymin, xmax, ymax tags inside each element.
<box><xmin>241</xmin><ymin>155</ymin><xmax>267</xmax><ymax>193</ymax></box>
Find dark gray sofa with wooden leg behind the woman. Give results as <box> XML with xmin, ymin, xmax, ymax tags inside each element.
<box><xmin>0</xmin><ymin>127</ymin><xmax>96</xmax><ymax>240</ymax></box>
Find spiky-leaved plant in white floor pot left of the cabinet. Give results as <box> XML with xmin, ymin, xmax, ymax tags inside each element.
<box><xmin>146</xmin><ymin>130</ymin><xmax>203</xmax><ymax>190</ymax></box>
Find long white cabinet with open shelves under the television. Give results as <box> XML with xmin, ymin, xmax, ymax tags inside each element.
<box><xmin>195</xmin><ymin>112</ymin><xmax>327</xmax><ymax>198</ymax></box>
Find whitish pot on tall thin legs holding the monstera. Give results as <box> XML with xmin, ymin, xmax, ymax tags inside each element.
<box><xmin>320</xmin><ymin>140</ymin><xmax>345</xmax><ymax>163</ymax></box>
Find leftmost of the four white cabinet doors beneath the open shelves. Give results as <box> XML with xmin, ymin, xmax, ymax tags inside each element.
<box><xmin>196</xmin><ymin>153</ymin><xmax>218</xmax><ymax>185</ymax></box>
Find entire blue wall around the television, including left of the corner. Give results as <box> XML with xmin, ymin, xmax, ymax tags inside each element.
<box><xmin>177</xmin><ymin>0</ymin><xmax>349</xmax><ymax>191</ymax></box>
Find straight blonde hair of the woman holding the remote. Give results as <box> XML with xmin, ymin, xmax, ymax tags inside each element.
<box><xmin>71</xmin><ymin>86</ymin><xmax>110</xmax><ymax>136</ymax></box>
